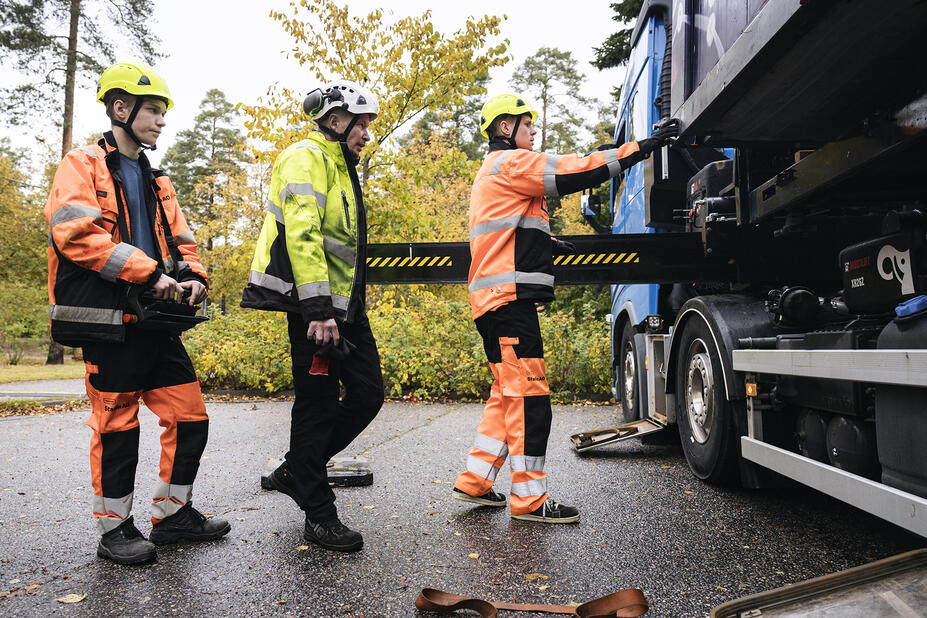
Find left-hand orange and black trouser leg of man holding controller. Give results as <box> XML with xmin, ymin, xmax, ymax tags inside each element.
<box><xmin>86</xmin><ymin>373</ymin><xmax>139</xmax><ymax>534</ymax></box>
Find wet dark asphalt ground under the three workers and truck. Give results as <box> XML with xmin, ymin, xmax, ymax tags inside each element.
<box><xmin>0</xmin><ymin>401</ymin><xmax>925</xmax><ymax>618</ymax></box>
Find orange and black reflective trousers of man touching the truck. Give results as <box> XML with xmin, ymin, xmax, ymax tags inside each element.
<box><xmin>454</xmin><ymin>301</ymin><xmax>551</xmax><ymax>515</ymax></box>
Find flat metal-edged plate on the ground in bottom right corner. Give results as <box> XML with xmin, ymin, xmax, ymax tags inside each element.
<box><xmin>711</xmin><ymin>549</ymin><xmax>927</xmax><ymax>618</ymax></box>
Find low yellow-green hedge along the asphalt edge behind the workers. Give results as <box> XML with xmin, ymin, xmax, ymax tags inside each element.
<box><xmin>184</xmin><ymin>287</ymin><xmax>610</xmax><ymax>402</ymax></box>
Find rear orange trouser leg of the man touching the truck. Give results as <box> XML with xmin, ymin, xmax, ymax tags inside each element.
<box><xmin>454</xmin><ymin>370</ymin><xmax>509</xmax><ymax>496</ymax></box>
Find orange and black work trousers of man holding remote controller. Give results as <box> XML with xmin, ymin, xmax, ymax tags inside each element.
<box><xmin>83</xmin><ymin>328</ymin><xmax>209</xmax><ymax>534</ymax></box>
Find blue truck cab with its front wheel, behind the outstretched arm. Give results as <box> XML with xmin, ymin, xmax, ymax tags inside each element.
<box><xmin>600</xmin><ymin>0</ymin><xmax>734</xmax><ymax>422</ymax></box>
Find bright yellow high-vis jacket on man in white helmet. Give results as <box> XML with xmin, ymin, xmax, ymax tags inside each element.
<box><xmin>241</xmin><ymin>131</ymin><xmax>367</xmax><ymax>322</ymax></box>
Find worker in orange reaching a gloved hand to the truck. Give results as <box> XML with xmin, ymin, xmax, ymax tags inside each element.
<box><xmin>453</xmin><ymin>94</ymin><xmax>678</xmax><ymax>523</ymax></box>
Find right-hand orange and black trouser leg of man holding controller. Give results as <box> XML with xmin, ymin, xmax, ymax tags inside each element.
<box><xmin>142</xmin><ymin>382</ymin><xmax>209</xmax><ymax>523</ymax></box>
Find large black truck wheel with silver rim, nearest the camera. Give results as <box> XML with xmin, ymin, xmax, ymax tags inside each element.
<box><xmin>676</xmin><ymin>319</ymin><xmax>737</xmax><ymax>484</ymax></box>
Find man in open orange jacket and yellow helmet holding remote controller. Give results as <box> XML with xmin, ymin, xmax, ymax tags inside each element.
<box><xmin>45</xmin><ymin>62</ymin><xmax>231</xmax><ymax>564</ymax></box>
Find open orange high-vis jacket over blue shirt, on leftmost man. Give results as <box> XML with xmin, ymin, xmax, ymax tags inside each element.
<box><xmin>45</xmin><ymin>133</ymin><xmax>208</xmax><ymax>346</ymax></box>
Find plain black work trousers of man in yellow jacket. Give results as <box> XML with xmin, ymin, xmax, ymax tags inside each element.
<box><xmin>286</xmin><ymin>313</ymin><xmax>383</xmax><ymax>521</ymax></box>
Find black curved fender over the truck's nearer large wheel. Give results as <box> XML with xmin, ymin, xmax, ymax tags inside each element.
<box><xmin>666</xmin><ymin>294</ymin><xmax>775</xmax><ymax>401</ymax></box>
